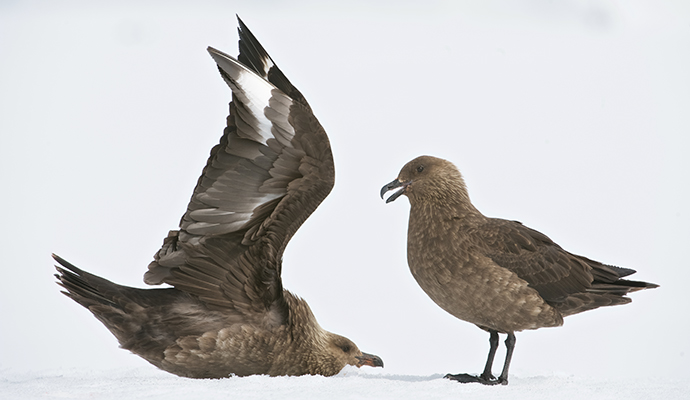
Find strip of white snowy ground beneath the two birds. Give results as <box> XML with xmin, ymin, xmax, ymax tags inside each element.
<box><xmin>0</xmin><ymin>367</ymin><xmax>690</xmax><ymax>400</ymax></box>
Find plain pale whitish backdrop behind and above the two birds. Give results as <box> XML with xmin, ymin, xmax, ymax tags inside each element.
<box><xmin>0</xmin><ymin>0</ymin><xmax>690</xmax><ymax>396</ymax></box>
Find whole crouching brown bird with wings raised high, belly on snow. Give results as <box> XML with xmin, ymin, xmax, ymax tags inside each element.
<box><xmin>53</xmin><ymin>16</ymin><xmax>383</xmax><ymax>378</ymax></box>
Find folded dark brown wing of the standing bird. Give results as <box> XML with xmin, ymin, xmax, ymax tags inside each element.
<box><xmin>478</xmin><ymin>219</ymin><xmax>635</xmax><ymax>302</ymax></box>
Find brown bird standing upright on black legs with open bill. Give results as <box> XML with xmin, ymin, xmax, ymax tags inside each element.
<box><xmin>381</xmin><ymin>156</ymin><xmax>657</xmax><ymax>384</ymax></box>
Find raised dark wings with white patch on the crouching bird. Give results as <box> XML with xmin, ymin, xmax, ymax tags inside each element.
<box><xmin>144</xmin><ymin>18</ymin><xmax>334</xmax><ymax>323</ymax></box>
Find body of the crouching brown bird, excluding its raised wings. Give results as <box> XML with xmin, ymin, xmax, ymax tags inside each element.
<box><xmin>54</xmin><ymin>256</ymin><xmax>356</xmax><ymax>378</ymax></box>
